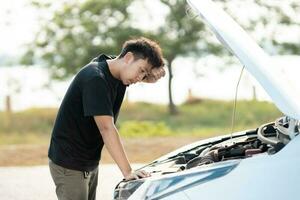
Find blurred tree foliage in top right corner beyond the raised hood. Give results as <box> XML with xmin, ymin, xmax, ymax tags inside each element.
<box><xmin>218</xmin><ymin>0</ymin><xmax>300</xmax><ymax>55</ymax></box>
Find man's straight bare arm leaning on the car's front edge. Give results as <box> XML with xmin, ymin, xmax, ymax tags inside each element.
<box><xmin>94</xmin><ymin>116</ymin><xmax>150</xmax><ymax>180</ymax></box>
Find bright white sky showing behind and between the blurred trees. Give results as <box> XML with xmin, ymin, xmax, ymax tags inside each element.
<box><xmin>0</xmin><ymin>0</ymin><xmax>300</xmax><ymax>110</ymax></box>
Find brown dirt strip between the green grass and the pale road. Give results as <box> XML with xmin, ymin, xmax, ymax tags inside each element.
<box><xmin>0</xmin><ymin>136</ymin><xmax>201</xmax><ymax>166</ymax></box>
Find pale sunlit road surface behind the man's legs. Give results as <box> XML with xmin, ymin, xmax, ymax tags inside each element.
<box><xmin>0</xmin><ymin>164</ymin><xmax>142</xmax><ymax>200</ymax></box>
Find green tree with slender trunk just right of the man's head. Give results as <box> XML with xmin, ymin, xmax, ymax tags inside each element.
<box><xmin>144</xmin><ymin>0</ymin><xmax>222</xmax><ymax>114</ymax></box>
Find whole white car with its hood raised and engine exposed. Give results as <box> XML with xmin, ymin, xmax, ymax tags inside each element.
<box><xmin>114</xmin><ymin>0</ymin><xmax>300</xmax><ymax>200</ymax></box>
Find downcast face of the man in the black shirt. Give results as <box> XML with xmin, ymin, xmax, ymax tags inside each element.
<box><xmin>120</xmin><ymin>54</ymin><xmax>152</xmax><ymax>85</ymax></box>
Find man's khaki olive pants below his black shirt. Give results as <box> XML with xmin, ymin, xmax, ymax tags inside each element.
<box><xmin>49</xmin><ymin>160</ymin><xmax>98</xmax><ymax>200</ymax></box>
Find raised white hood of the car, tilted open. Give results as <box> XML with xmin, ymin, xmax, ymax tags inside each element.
<box><xmin>187</xmin><ymin>0</ymin><xmax>300</xmax><ymax>120</ymax></box>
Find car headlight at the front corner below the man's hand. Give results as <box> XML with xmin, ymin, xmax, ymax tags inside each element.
<box><xmin>114</xmin><ymin>180</ymin><xmax>144</xmax><ymax>200</ymax></box>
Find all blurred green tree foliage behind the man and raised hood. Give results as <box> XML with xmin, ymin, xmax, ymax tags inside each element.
<box><xmin>22</xmin><ymin>0</ymin><xmax>300</xmax><ymax>114</ymax></box>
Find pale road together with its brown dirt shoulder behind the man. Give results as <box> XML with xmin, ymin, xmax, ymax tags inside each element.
<box><xmin>0</xmin><ymin>137</ymin><xmax>200</xmax><ymax>200</ymax></box>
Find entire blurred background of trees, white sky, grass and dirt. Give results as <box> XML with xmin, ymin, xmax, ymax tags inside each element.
<box><xmin>0</xmin><ymin>0</ymin><xmax>300</xmax><ymax>166</ymax></box>
